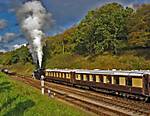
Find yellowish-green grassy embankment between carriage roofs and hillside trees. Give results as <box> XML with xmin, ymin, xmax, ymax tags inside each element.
<box><xmin>46</xmin><ymin>49</ymin><xmax>150</xmax><ymax>70</ymax></box>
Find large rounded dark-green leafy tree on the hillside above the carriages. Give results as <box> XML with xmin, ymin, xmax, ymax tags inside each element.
<box><xmin>73</xmin><ymin>3</ymin><xmax>133</xmax><ymax>54</ymax></box>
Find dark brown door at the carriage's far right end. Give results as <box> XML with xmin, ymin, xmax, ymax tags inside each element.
<box><xmin>143</xmin><ymin>75</ymin><xmax>150</xmax><ymax>95</ymax></box>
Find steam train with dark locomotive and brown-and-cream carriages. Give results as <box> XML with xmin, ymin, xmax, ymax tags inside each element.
<box><xmin>35</xmin><ymin>69</ymin><xmax>150</xmax><ymax>102</ymax></box>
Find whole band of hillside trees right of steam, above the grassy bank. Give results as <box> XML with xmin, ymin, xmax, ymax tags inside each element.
<box><xmin>45</xmin><ymin>3</ymin><xmax>150</xmax><ymax>56</ymax></box>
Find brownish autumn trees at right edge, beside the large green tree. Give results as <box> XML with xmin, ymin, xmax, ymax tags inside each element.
<box><xmin>127</xmin><ymin>4</ymin><xmax>150</xmax><ymax>47</ymax></box>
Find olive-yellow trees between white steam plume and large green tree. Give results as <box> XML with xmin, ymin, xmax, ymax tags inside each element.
<box><xmin>44</xmin><ymin>27</ymin><xmax>76</xmax><ymax>57</ymax></box>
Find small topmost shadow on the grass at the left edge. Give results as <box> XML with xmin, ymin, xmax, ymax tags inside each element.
<box><xmin>0</xmin><ymin>82</ymin><xmax>12</xmax><ymax>93</ymax></box>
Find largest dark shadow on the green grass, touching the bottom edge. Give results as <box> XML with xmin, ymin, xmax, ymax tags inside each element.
<box><xmin>4</xmin><ymin>100</ymin><xmax>35</xmax><ymax>116</ymax></box>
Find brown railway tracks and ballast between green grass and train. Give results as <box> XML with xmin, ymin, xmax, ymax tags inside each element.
<box><xmin>10</xmin><ymin>76</ymin><xmax>150</xmax><ymax>116</ymax></box>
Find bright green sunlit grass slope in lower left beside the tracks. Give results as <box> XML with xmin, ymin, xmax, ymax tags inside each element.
<box><xmin>0</xmin><ymin>73</ymin><xmax>88</xmax><ymax>116</ymax></box>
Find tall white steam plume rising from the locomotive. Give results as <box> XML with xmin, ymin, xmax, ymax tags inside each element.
<box><xmin>17</xmin><ymin>0</ymin><xmax>53</xmax><ymax>68</ymax></box>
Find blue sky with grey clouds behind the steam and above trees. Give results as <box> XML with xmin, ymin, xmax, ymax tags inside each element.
<box><xmin>0</xmin><ymin>0</ymin><xmax>150</xmax><ymax>52</ymax></box>
